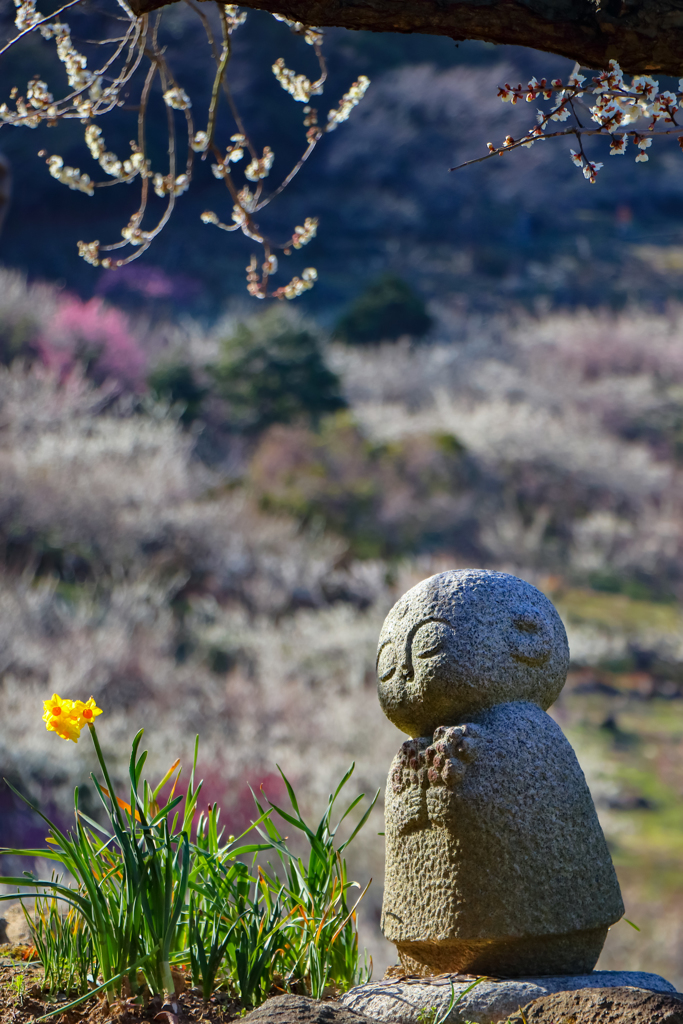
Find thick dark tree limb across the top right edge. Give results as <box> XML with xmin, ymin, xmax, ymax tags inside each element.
<box><xmin>132</xmin><ymin>0</ymin><xmax>683</xmax><ymax>76</ymax></box>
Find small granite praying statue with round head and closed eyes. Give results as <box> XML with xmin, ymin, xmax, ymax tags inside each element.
<box><xmin>378</xmin><ymin>569</ymin><xmax>624</xmax><ymax>977</ymax></box>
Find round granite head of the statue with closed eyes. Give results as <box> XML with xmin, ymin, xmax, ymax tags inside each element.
<box><xmin>377</xmin><ymin>569</ymin><xmax>569</xmax><ymax>736</ymax></box>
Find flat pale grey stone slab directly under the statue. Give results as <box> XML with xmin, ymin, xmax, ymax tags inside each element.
<box><xmin>340</xmin><ymin>971</ymin><xmax>676</xmax><ymax>1024</ymax></box>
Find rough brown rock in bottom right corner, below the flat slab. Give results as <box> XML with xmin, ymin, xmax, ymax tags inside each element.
<box><xmin>510</xmin><ymin>988</ymin><xmax>683</xmax><ymax>1024</ymax></box>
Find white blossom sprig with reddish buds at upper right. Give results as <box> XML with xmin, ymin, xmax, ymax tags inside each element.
<box><xmin>466</xmin><ymin>60</ymin><xmax>683</xmax><ymax>184</ymax></box>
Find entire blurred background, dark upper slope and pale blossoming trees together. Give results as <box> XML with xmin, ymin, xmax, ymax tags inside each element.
<box><xmin>0</xmin><ymin>4</ymin><xmax>683</xmax><ymax>987</ymax></box>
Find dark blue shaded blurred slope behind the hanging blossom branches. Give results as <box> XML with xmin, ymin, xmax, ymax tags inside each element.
<box><xmin>0</xmin><ymin>7</ymin><xmax>683</xmax><ymax>322</ymax></box>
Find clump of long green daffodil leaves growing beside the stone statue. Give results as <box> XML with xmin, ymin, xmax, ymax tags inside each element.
<box><xmin>0</xmin><ymin>725</ymin><xmax>379</xmax><ymax>1016</ymax></box>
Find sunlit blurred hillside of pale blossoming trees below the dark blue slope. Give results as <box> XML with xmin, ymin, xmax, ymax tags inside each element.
<box><xmin>0</xmin><ymin>270</ymin><xmax>683</xmax><ymax>986</ymax></box>
